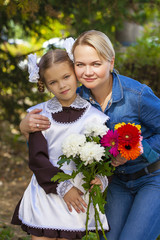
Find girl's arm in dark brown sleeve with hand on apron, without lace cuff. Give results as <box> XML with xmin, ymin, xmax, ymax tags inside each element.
<box><xmin>29</xmin><ymin>131</ymin><xmax>87</xmax><ymax>213</ymax></box>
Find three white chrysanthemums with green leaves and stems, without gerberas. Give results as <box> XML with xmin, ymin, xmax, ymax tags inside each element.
<box><xmin>52</xmin><ymin>122</ymin><xmax>114</xmax><ymax>240</ymax></box>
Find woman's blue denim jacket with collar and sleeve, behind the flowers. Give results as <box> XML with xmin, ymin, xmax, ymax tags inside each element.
<box><xmin>77</xmin><ymin>71</ymin><xmax>160</xmax><ymax>174</ymax></box>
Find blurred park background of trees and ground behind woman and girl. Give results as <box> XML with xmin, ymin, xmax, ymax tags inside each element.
<box><xmin>0</xmin><ymin>0</ymin><xmax>160</xmax><ymax>240</ymax></box>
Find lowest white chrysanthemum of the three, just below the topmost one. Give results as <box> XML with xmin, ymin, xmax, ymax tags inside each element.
<box><xmin>80</xmin><ymin>142</ymin><xmax>105</xmax><ymax>165</ymax></box>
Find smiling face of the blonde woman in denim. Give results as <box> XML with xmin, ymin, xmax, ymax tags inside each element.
<box><xmin>74</xmin><ymin>45</ymin><xmax>114</xmax><ymax>90</ymax></box>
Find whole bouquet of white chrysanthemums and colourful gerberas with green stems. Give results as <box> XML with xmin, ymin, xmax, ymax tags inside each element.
<box><xmin>52</xmin><ymin>122</ymin><xmax>143</xmax><ymax>240</ymax></box>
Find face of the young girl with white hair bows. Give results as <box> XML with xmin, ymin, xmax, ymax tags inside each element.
<box><xmin>44</xmin><ymin>62</ymin><xmax>77</xmax><ymax>107</ymax></box>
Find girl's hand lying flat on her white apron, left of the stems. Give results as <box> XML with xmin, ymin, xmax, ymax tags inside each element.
<box><xmin>63</xmin><ymin>187</ymin><xmax>87</xmax><ymax>213</ymax></box>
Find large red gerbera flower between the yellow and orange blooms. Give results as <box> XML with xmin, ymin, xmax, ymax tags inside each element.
<box><xmin>117</xmin><ymin>124</ymin><xmax>140</xmax><ymax>147</ymax></box>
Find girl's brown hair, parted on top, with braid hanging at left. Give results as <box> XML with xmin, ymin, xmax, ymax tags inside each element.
<box><xmin>37</xmin><ymin>49</ymin><xmax>73</xmax><ymax>92</ymax></box>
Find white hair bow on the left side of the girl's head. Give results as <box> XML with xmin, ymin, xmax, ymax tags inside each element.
<box><xmin>28</xmin><ymin>53</ymin><xmax>39</xmax><ymax>83</ymax></box>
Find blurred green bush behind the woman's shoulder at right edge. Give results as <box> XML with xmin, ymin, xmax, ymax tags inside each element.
<box><xmin>115</xmin><ymin>25</ymin><xmax>160</xmax><ymax>97</ymax></box>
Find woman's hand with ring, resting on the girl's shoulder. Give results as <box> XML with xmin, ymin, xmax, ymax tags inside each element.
<box><xmin>19</xmin><ymin>109</ymin><xmax>50</xmax><ymax>139</ymax></box>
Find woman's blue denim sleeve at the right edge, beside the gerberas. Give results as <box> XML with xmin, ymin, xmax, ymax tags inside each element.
<box><xmin>140</xmin><ymin>86</ymin><xmax>160</xmax><ymax>162</ymax></box>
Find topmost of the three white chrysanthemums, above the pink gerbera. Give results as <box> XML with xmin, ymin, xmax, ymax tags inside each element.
<box><xmin>84</xmin><ymin>121</ymin><xmax>108</xmax><ymax>137</ymax></box>
